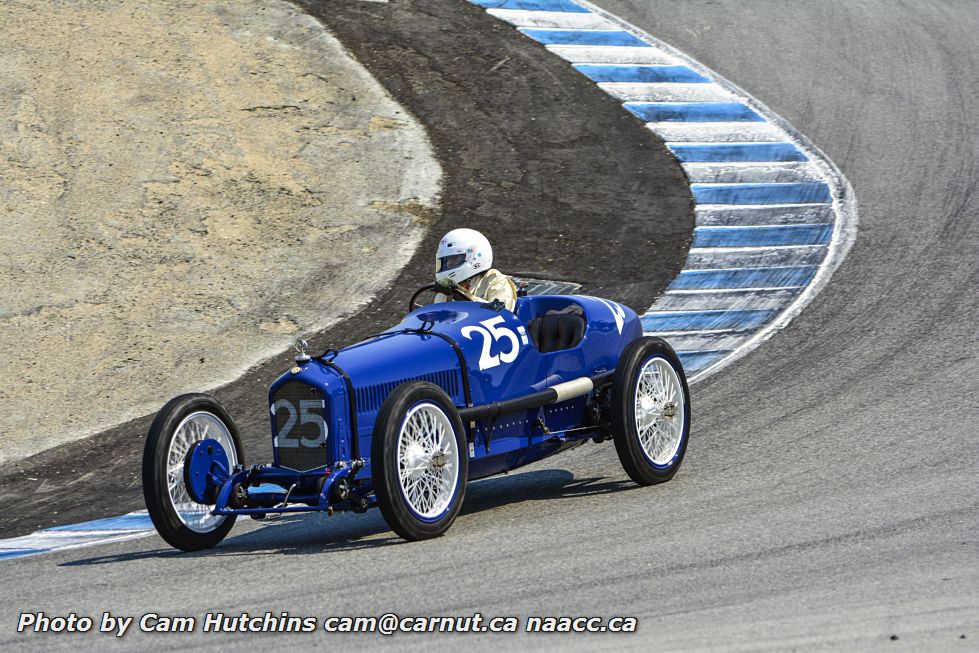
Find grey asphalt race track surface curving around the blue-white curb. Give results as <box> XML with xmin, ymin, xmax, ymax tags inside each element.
<box><xmin>0</xmin><ymin>0</ymin><xmax>979</xmax><ymax>651</ymax></box>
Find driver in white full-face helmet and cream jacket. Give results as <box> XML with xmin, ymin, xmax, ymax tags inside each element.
<box><xmin>435</xmin><ymin>229</ymin><xmax>517</xmax><ymax>311</ymax></box>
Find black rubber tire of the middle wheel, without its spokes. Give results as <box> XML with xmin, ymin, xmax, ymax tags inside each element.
<box><xmin>371</xmin><ymin>381</ymin><xmax>469</xmax><ymax>540</ymax></box>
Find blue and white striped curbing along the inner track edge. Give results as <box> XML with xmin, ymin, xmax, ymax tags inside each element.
<box><xmin>0</xmin><ymin>0</ymin><xmax>857</xmax><ymax>560</ymax></box>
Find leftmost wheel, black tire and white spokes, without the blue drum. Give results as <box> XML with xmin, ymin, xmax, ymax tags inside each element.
<box><xmin>143</xmin><ymin>394</ymin><xmax>244</xmax><ymax>551</ymax></box>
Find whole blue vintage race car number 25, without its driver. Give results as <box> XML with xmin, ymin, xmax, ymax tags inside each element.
<box><xmin>143</xmin><ymin>286</ymin><xmax>690</xmax><ymax>551</ymax></box>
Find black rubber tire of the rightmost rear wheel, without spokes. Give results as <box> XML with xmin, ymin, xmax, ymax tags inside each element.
<box><xmin>611</xmin><ymin>336</ymin><xmax>690</xmax><ymax>485</ymax></box>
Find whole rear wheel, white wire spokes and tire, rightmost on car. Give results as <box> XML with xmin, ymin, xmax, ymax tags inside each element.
<box><xmin>612</xmin><ymin>337</ymin><xmax>690</xmax><ymax>485</ymax></box>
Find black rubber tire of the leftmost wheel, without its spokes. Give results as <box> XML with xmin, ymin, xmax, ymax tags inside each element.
<box><xmin>143</xmin><ymin>393</ymin><xmax>244</xmax><ymax>551</ymax></box>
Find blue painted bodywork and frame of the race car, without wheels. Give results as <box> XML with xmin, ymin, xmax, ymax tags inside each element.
<box><xmin>206</xmin><ymin>295</ymin><xmax>642</xmax><ymax>517</ymax></box>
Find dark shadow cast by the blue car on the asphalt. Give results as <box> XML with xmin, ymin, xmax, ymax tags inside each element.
<box><xmin>60</xmin><ymin>469</ymin><xmax>637</xmax><ymax>567</ymax></box>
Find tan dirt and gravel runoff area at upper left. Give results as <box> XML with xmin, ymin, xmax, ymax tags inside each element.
<box><xmin>0</xmin><ymin>0</ymin><xmax>441</xmax><ymax>462</ymax></box>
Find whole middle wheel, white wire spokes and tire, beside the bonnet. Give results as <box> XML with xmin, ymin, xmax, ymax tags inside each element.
<box><xmin>371</xmin><ymin>381</ymin><xmax>469</xmax><ymax>540</ymax></box>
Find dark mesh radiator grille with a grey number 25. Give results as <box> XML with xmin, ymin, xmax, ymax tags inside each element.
<box><xmin>272</xmin><ymin>381</ymin><xmax>330</xmax><ymax>471</ymax></box>
